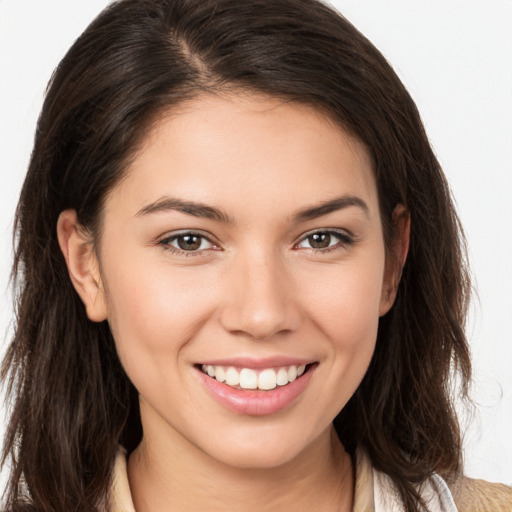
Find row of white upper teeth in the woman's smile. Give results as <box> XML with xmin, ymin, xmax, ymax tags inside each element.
<box><xmin>201</xmin><ymin>365</ymin><xmax>306</xmax><ymax>391</ymax></box>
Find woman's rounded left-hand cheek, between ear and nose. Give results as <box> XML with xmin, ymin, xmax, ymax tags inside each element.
<box><xmin>101</xmin><ymin>254</ymin><xmax>215</xmax><ymax>376</ymax></box>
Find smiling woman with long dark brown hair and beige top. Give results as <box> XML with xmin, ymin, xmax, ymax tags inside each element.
<box><xmin>4</xmin><ymin>0</ymin><xmax>510</xmax><ymax>512</ymax></box>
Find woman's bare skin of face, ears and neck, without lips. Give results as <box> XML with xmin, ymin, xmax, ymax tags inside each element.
<box><xmin>58</xmin><ymin>94</ymin><xmax>408</xmax><ymax>512</ymax></box>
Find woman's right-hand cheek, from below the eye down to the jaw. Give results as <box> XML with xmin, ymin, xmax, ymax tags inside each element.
<box><xmin>286</xmin><ymin>260</ymin><xmax>383</xmax><ymax>428</ymax></box>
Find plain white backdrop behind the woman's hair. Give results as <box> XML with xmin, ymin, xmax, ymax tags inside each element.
<box><xmin>0</xmin><ymin>0</ymin><xmax>512</xmax><ymax>489</ymax></box>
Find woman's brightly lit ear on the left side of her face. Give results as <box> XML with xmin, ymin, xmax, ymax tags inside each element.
<box><xmin>57</xmin><ymin>210</ymin><xmax>107</xmax><ymax>322</ymax></box>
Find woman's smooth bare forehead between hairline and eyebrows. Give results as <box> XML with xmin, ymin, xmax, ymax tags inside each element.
<box><xmin>107</xmin><ymin>93</ymin><xmax>377</xmax><ymax>222</ymax></box>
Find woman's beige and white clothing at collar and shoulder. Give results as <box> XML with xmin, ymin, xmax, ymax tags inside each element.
<box><xmin>109</xmin><ymin>450</ymin><xmax>512</xmax><ymax>512</ymax></box>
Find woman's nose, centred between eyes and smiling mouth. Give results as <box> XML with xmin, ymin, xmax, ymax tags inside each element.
<box><xmin>221</xmin><ymin>249</ymin><xmax>301</xmax><ymax>340</ymax></box>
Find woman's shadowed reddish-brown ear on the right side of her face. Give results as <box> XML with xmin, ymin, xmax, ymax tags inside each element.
<box><xmin>379</xmin><ymin>204</ymin><xmax>411</xmax><ymax>316</ymax></box>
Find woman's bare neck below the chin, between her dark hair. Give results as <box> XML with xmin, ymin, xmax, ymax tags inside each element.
<box><xmin>128</xmin><ymin>427</ymin><xmax>354</xmax><ymax>512</ymax></box>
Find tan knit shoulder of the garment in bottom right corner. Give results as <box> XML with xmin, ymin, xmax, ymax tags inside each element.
<box><xmin>449</xmin><ymin>477</ymin><xmax>512</xmax><ymax>512</ymax></box>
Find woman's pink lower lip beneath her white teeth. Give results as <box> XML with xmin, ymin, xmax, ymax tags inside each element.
<box><xmin>197</xmin><ymin>365</ymin><xmax>316</xmax><ymax>416</ymax></box>
